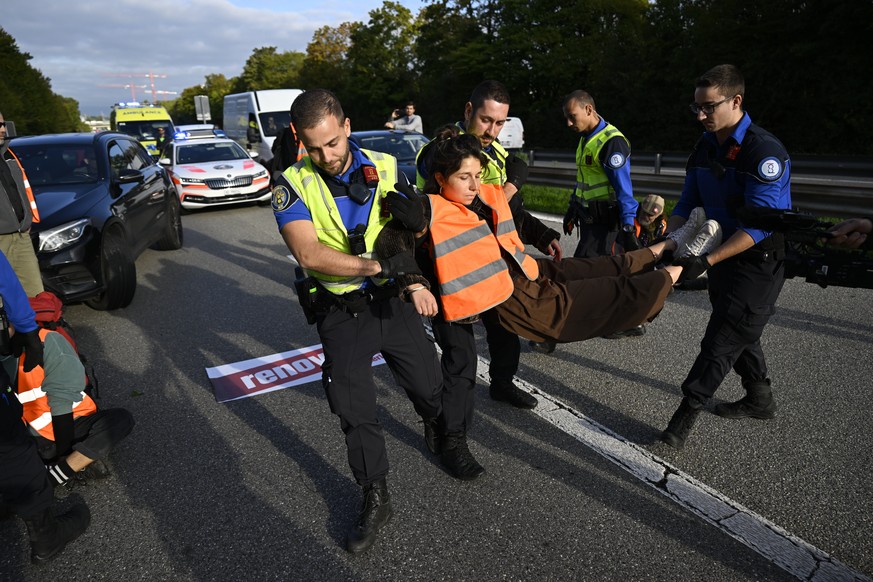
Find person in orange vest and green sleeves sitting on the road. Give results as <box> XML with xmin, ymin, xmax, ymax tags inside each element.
<box><xmin>2</xmin><ymin>310</ymin><xmax>134</xmax><ymax>489</ymax></box>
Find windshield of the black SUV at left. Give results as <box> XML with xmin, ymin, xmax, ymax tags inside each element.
<box><xmin>12</xmin><ymin>144</ymin><xmax>100</xmax><ymax>187</ymax></box>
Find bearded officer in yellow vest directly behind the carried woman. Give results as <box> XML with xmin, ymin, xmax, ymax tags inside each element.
<box><xmin>416</xmin><ymin>80</ymin><xmax>562</xmax><ymax>408</ymax></box>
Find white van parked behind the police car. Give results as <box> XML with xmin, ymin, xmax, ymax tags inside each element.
<box><xmin>224</xmin><ymin>89</ymin><xmax>303</xmax><ymax>163</ymax></box>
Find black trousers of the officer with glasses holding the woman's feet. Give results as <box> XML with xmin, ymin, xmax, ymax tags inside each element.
<box><xmin>682</xmin><ymin>250</ymin><xmax>785</xmax><ymax>402</ymax></box>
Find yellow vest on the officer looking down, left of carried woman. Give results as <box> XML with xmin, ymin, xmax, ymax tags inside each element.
<box><xmin>285</xmin><ymin>149</ymin><xmax>397</xmax><ymax>295</ymax></box>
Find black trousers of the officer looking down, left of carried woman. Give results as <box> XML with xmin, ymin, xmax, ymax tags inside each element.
<box><xmin>316</xmin><ymin>297</ymin><xmax>442</xmax><ymax>486</ymax></box>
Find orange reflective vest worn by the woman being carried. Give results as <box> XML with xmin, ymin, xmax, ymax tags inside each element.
<box><xmin>428</xmin><ymin>184</ymin><xmax>539</xmax><ymax>321</ymax></box>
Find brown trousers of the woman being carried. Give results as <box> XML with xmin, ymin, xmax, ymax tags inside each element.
<box><xmin>494</xmin><ymin>249</ymin><xmax>673</xmax><ymax>343</ymax></box>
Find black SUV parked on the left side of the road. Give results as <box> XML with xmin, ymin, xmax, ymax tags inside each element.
<box><xmin>9</xmin><ymin>132</ymin><xmax>182</xmax><ymax>310</ymax></box>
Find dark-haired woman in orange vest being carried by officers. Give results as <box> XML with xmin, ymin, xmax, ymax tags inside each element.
<box><xmin>383</xmin><ymin>128</ymin><xmax>683</xmax><ymax>342</ymax></box>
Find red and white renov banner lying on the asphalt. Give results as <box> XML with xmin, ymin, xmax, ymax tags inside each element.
<box><xmin>206</xmin><ymin>344</ymin><xmax>385</xmax><ymax>402</ymax></box>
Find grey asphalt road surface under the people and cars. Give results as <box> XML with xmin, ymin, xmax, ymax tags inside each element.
<box><xmin>0</xmin><ymin>207</ymin><xmax>873</xmax><ymax>581</ymax></box>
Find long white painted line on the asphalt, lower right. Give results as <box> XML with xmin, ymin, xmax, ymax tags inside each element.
<box><xmin>477</xmin><ymin>356</ymin><xmax>871</xmax><ymax>582</ymax></box>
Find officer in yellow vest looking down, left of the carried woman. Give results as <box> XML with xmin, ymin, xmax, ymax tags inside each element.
<box><xmin>273</xmin><ymin>89</ymin><xmax>442</xmax><ymax>553</ymax></box>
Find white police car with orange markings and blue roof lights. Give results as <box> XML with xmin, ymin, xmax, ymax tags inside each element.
<box><xmin>160</xmin><ymin>126</ymin><xmax>271</xmax><ymax>210</ymax></box>
